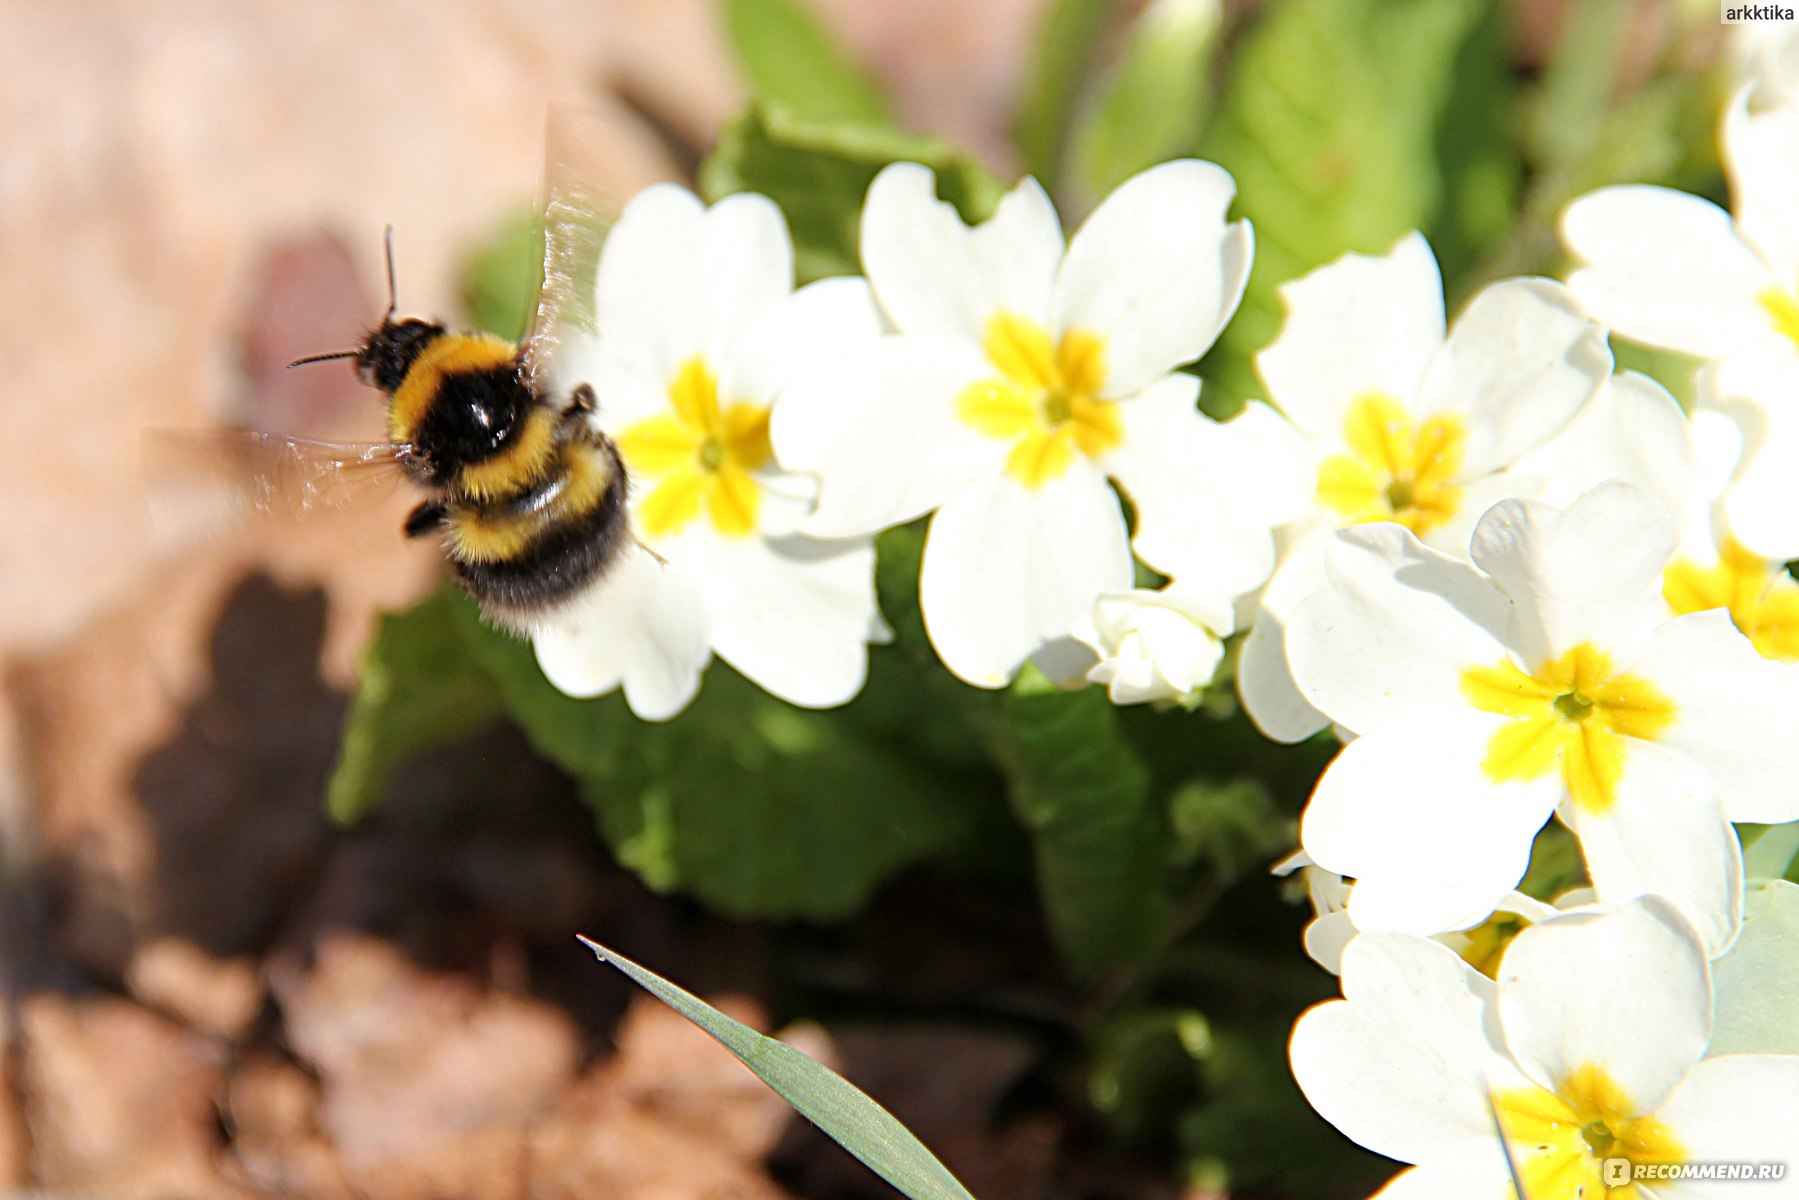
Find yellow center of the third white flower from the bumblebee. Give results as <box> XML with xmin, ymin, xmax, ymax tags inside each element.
<box><xmin>1319</xmin><ymin>392</ymin><xmax>1468</xmax><ymax>534</ymax></box>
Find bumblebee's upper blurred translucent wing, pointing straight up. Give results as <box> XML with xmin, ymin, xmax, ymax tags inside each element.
<box><xmin>525</xmin><ymin>106</ymin><xmax>606</xmax><ymax>392</ymax></box>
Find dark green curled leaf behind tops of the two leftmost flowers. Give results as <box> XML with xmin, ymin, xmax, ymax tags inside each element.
<box><xmin>700</xmin><ymin>106</ymin><xmax>1002</xmax><ymax>282</ymax></box>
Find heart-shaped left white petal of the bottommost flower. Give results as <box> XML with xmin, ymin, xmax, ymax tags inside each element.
<box><xmin>1288</xmin><ymin>934</ymin><xmax>1504</xmax><ymax>1173</ymax></box>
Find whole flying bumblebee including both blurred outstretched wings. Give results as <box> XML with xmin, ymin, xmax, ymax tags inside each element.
<box><xmin>157</xmin><ymin>121</ymin><xmax>640</xmax><ymax>635</ymax></box>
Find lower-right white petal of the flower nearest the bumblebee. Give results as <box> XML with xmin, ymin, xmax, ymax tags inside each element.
<box><xmin>707</xmin><ymin>538</ymin><xmax>876</xmax><ymax>709</ymax></box>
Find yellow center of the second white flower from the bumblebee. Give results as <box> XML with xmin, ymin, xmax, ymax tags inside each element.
<box><xmin>955</xmin><ymin>313</ymin><xmax>1124</xmax><ymax>488</ymax></box>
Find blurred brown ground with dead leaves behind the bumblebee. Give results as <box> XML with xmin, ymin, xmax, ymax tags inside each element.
<box><xmin>0</xmin><ymin>0</ymin><xmax>1049</xmax><ymax>1198</ymax></box>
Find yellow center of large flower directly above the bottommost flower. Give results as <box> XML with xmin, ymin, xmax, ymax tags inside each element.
<box><xmin>1461</xmin><ymin>642</ymin><xmax>1675</xmax><ymax>813</ymax></box>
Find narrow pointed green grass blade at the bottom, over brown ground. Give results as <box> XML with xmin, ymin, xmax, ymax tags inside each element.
<box><xmin>581</xmin><ymin>937</ymin><xmax>973</xmax><ymax>1200</ymax></box>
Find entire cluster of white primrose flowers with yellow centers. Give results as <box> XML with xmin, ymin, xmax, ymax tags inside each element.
<box><xmin>521</xmin><ymin>58</ymin><xmax>1799</xmax><ymax>1200</ymax></box>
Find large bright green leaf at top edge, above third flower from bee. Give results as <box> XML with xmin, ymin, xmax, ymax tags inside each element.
<box><xmin>1202</xmin><ymin>0</ymin><xmax>1490</xmax><ymax>410</ymax></box>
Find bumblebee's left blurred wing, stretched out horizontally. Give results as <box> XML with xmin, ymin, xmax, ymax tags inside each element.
<box><xmin>144</xmin><ymin>428</ymin><xmax>407</xmax><ymax>534</ymax></box>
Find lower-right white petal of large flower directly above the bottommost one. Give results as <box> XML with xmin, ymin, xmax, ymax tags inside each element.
<box><xmin>1560</xmin><ymin>741</ymin><xmax>1743</xmax><ymax>954</ymax></box>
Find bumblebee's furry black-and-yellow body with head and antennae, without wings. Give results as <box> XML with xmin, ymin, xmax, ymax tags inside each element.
<box><xmin>288</xmin><ymin>228</ymin><xmax>631</xmax><ymax>631</ymax></box>
